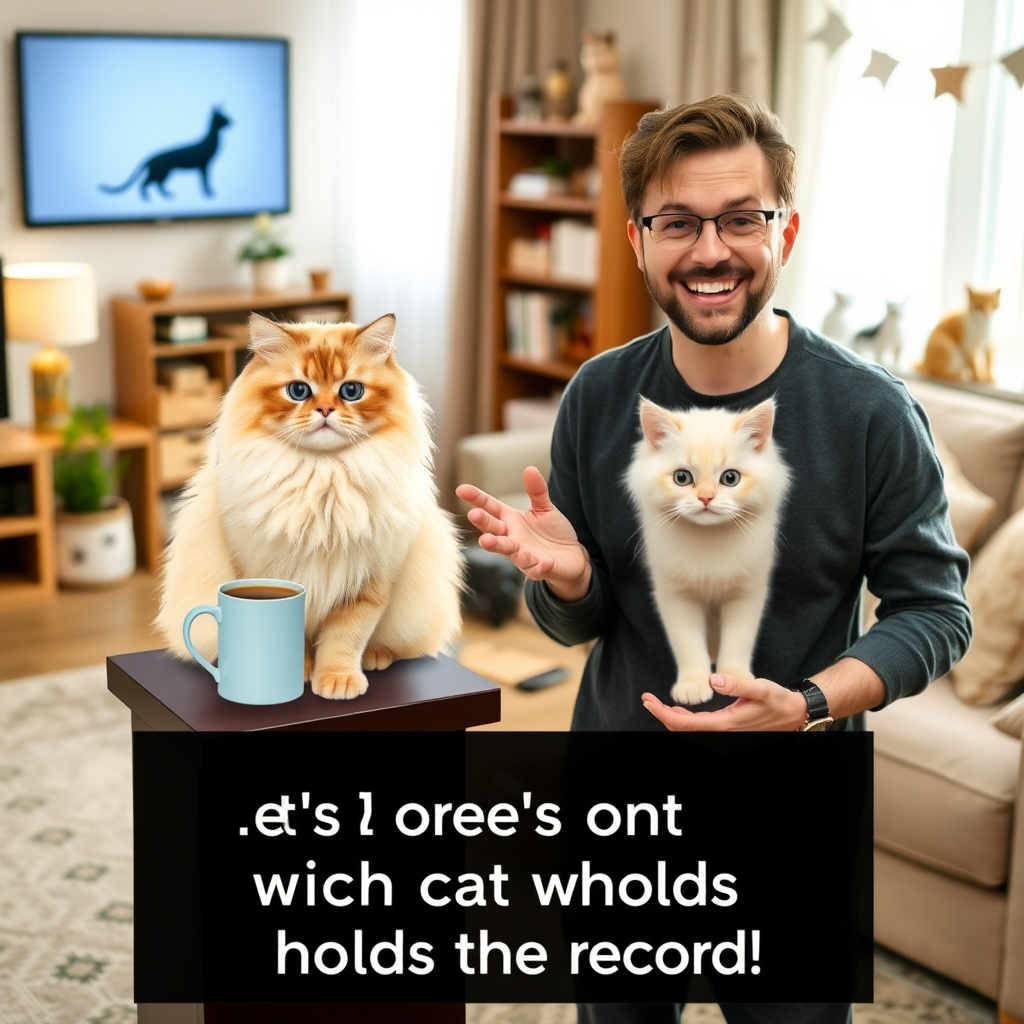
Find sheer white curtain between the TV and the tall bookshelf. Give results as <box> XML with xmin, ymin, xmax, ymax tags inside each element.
<box><xmin>331</xmin><ymin>0</ymin><xmax>465</xmax><ymax>423</ymax></box>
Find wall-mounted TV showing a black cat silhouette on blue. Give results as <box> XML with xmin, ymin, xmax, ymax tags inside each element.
<box><xmin>16</xmin><ymin>32</ymin><xmax>289</xmax><ymax>227</ymax></box>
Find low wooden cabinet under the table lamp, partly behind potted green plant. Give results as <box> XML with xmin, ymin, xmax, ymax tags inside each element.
<box><xmin>0</xmin><ymin>420</ymin><xmax>161</xmax><ymax>608</ymax></box>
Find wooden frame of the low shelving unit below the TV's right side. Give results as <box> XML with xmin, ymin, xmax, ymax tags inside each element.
<box><xmin>113</xmin><ymin>290</ymin><xmax>351</xmax><ymax>499</ymax></box>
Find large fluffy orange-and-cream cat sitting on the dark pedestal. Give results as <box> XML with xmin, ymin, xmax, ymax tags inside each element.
<box><xmin>156</xmin><ymin>313</ymin><xmax>463</xmax><ymax>699</ymax></box>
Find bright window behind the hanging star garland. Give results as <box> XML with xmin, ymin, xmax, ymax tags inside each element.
<box><xmin>791</xmin><ymin>0</ymin><xmax>1024</xmax><ymax>390</ymax></box>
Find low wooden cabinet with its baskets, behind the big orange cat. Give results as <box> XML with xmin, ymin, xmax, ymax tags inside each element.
<box><xmin>113</xmin><ymin>291</ymin><xmax>351</xmax><ymax>492</ymax></box>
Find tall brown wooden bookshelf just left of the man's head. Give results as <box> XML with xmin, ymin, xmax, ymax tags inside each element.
<box><xmin>487</xmin><ymin>96</ymin><xmax>657</xmax><ymax>430</ymax></box>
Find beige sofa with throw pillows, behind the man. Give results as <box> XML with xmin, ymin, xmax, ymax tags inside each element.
<box><xmin>457</xmin><ymin>379</ymin><xmax>1024</xmax><ymax>1024</ymax></box>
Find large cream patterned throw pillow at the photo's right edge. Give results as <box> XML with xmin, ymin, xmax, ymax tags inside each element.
<box><xmin>951</xmin><ymin>510</ymin><xmax>1024</xmax><ymax>705</ymax></box>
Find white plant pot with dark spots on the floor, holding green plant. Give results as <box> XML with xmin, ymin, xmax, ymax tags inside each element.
<box><xmin>56</xmin><ymin>496</ymin><xmax>135</xmax><ymax>587</ymax></box>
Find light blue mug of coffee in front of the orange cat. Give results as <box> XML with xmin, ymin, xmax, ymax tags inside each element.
<box><xmin>181</xmin><ymin>580</ymin><xmax>306</xmax><ymax>705</ymax></box>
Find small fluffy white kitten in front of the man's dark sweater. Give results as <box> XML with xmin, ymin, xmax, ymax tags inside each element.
<box><xmin>626</xmin><ymin>398</ymin><xmax>790</xmax><ymax>705</ymax></box>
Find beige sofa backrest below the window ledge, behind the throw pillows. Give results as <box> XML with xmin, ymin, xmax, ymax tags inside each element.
<box><xmin>906</xmin><ymin>379</ymin><xmax>1024</xmax><ymax>542</ymax></box>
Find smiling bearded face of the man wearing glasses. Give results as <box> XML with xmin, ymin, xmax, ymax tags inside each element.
<box><xmin>627</xmin><ymin>142</ymin><xmax>799</xmax><ymax>345</ymax></box>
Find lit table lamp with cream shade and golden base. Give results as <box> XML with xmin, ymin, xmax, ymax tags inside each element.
<box><xmin>3</xmin><ymin>263</ymin><xmax>99</xmax><ymax>432</ymax></box>
